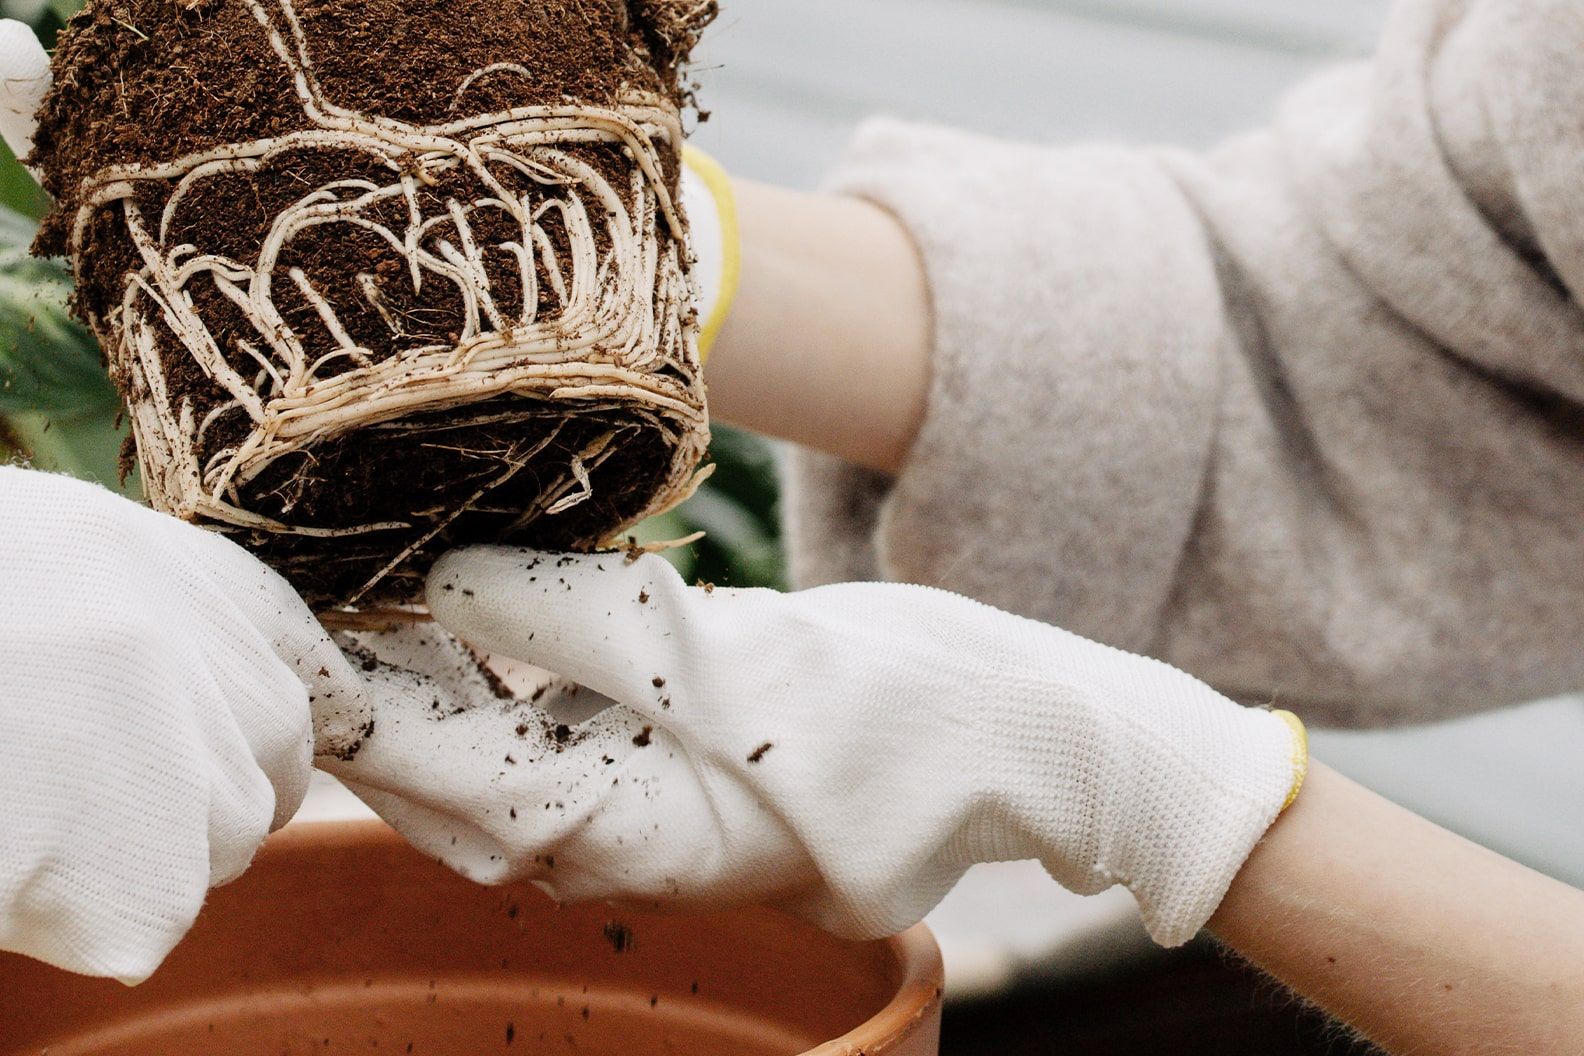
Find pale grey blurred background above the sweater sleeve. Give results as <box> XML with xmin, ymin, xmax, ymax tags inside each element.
<box><xmin>697</xmin><ymin>0</ymin><xmax>1388</xmax><ymax>185</ymax></box>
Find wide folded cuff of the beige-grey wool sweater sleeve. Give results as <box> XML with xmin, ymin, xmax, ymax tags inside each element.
<box><xmin>787</xmin><ymin>120</ymin><xmax>1229</xmax><ymax>649</ymax></box>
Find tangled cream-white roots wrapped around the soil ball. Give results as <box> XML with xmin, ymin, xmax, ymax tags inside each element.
<box><xmin>71</xmin><ymin>0</ymin><xmax>708</xmax><ymax>594</ymax></box>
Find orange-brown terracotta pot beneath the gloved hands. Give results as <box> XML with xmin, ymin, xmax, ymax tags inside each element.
<box><xmin>0</xmin><ymin>823</ymin><xmax>941</xmax><ymax>1056</ymax></box>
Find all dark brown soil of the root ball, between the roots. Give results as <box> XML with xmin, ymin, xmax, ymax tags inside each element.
<box><xmin>33</xmin><ymin>0</ymin><xmax>714</xmax><ymax>606</ymax></box>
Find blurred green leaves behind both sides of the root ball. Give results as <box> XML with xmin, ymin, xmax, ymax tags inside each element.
<box><xmin>0</xmin><ymin>0</ymin><xmax>786</xmax><ymax>587</ymax></box>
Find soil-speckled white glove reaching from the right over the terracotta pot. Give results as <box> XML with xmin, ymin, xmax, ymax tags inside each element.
<box><xmin>327</xmin><ymin>548</ymin><xmax>1307</xmax><ymax>945</ymax></box>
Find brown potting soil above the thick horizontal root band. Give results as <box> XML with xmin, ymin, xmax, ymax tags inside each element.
<box><xmin>32</xmin><ymin>0</ymin><xmax>716</xmax><ymax>255</ymax></box>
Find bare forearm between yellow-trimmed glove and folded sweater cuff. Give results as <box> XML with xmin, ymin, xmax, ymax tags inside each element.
<box><xmin>710</xmin><ymin>180</ymin><xmax>930</xmax><ymax>470</ymax></box>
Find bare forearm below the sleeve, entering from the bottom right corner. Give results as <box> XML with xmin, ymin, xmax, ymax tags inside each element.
<box><xmin>1210</xmin><ymin>765</ymin><xmax>1584</xmax><ymax>1054</ymax></box>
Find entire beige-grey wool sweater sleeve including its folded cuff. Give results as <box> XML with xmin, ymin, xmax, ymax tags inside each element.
<box><xmin>786</xmin><ymin>0</ymin><xmax>1584</xmax><ymax>725</ymax></box>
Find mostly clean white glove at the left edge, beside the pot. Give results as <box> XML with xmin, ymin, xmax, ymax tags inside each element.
<box><xmin>0</xmin><ymin>467</ymin><xmax>364</xmax><ymax>983</ymax></box>
